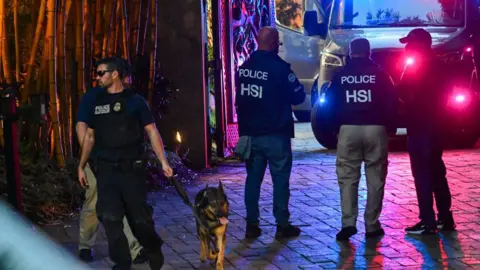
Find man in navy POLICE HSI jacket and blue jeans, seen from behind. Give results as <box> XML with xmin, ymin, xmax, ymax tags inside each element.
<box><xmin>236</xmin><ymin>27</ymin><xmax>305</xmax><ymax>238</ymax></box>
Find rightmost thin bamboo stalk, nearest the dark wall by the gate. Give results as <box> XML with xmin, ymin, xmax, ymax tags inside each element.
<box><xmin>147</xmin><ymin>0</ymin><xmax>158</xmax><ymax>106</ymax></box>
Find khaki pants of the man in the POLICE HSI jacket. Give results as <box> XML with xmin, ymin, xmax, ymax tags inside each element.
<box><xmin>336</xmin><ymin>125</ymin><xmax>388</xmax><ymax>232</ymax></box>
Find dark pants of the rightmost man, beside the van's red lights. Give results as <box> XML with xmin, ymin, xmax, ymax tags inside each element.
<box><xmin>408</xmin><ymin>134</ymin><xmax>452</xmax><ymax>226</ymax></box>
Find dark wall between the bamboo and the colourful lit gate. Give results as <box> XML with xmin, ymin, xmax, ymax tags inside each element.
<box><xmin>157</xmin><ymin>0</ymin><xmax>207</xmax><ymax>169</ymax></box>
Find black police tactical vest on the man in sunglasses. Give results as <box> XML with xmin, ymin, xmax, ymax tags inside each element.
<box><xmin>93</xmin><ymin>90</ymin><xmax>144</xmax><ymax>161</ymax></box>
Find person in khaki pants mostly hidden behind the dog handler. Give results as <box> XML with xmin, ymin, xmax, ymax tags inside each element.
<box><xmin>76</xmin><ymin>85</ymin><xmax>148</xmax><ymax>264</ymax></box>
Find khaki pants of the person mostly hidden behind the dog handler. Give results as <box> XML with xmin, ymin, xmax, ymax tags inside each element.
<box><xmin>78</xmin><ymin>165</ymin><xmax>142</xmax><ymax>259</ymax></box>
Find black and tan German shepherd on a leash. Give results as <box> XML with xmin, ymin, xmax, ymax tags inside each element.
<box><xmin>195</xmin><ymin>181</ymin><xmax>230</xmax><ymax>270</ymax></box>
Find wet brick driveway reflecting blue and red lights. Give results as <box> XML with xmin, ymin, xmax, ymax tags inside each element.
<box><xmin>45</xmin><ymin>124</ymin><xmax>480</xmax><ymax>269</ymax></box>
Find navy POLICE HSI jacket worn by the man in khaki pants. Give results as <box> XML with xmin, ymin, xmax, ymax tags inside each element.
<box><xmin>325</xmin><ymin>58</ymin><xmax>398</xmax><ymax>131</ymax></box>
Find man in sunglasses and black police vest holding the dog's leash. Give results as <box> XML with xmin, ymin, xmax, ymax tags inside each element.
<box><xmin>78</xmin><ymin>58</ymin><xmax>173</xmax><ymax>270</ymax></box>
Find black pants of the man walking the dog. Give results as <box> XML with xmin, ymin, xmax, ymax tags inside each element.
<box><xmin>97</xmin><ymin>161</ymin><xmax>163</xmax><ymax>269</ymax></box>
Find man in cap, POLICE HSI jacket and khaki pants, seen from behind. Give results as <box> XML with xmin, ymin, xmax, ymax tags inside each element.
<box><xmin>326</xmin><ymin>38</ymin><xmax>398</xmax><ymax>240</ymax></box>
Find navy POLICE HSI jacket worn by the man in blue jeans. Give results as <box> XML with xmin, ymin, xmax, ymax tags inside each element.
<box><xmin>235</xmin><ymin>51</ymin><xmax>306</xmax><ymax>138</ymax></box>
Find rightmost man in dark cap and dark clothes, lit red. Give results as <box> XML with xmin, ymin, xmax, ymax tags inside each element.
<box><xmin>400</xmin><ymin>28</ymin><xmax>455</xmax><ymax>234</ymax></box>
